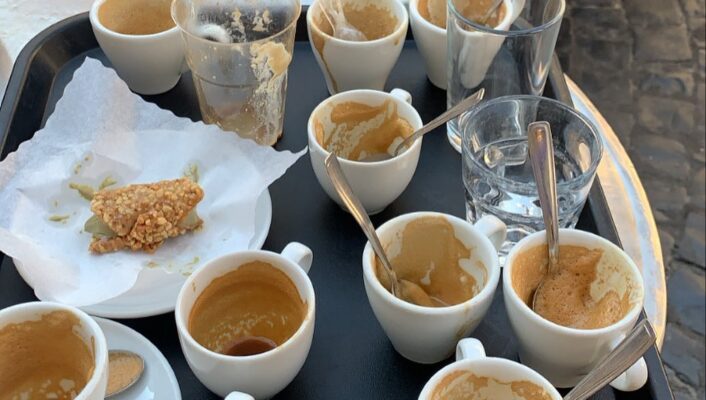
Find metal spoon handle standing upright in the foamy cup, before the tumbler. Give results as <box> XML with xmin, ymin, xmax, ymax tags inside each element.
<box><xmin>527</xmin><ymin>121</ymin><xmax>559</xmax><ymax>274</ymax></box>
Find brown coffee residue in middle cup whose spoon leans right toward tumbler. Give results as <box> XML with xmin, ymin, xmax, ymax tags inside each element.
<box><xmin>314</xmin><ymin>100</ymin><xmax>414</xmax><ymax>161</ymax></box>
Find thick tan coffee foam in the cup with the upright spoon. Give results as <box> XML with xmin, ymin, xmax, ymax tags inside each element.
<box><xmin>512</xmin><ymin>245</ymin><xmax>641</xmax><ymax>329</ymax></box>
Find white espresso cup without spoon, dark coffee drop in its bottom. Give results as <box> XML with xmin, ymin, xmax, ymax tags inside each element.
<box><xmin>174</xmin><ymin>243</ymin><xmax>315</xmax><ymax>399</ymax></box>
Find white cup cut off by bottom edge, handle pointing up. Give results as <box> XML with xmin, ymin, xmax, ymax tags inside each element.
<box><xmin>419</xmin><ymin>338</ymin><xmax>562</xmax><ymax>400</ymax></box>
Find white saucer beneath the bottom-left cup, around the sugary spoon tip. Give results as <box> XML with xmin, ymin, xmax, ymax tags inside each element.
<box><xmin>93</xmin><ymin>317</ymin><xmax>181</xmax><ymax>400</ymax></box>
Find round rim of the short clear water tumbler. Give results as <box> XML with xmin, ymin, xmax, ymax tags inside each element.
<box><xmin>462</xmin><ymin>95</ymin><xmax>604</xmax><ymax>188</ymax></box>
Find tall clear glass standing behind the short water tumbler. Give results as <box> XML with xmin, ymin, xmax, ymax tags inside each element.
<box><xmin>447</xmin><ymin>0</ymin><xmax>565</xmax><ymax>151</ymax></box>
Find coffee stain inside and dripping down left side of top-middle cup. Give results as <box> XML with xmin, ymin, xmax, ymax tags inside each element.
<box><xmin>310</xmin><ymin>1</ymin><xmax>400</xmax><ymax>93</ymax></box>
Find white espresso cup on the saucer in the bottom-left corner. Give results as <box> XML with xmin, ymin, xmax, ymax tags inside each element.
<box><xmin>0</xmin><ymin>302</ymin><xmax>108</xmax><ymax>400</ymax></box>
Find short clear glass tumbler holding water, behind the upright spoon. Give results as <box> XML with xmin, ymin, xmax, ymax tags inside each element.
<box><xmin>459</xmin><ymin>96</ymin><xmax>603</xmax><ymax>255</ymax></box>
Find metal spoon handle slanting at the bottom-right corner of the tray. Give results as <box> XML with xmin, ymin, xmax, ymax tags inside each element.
<box><xmin>564</xmin><ymin>319</ymin><xmax>657</xmax><ymax>400</ymax></box>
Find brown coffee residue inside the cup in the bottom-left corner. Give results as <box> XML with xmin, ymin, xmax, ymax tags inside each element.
<box><xmin>0</xmin><ymin>311</ymin><xmax>95</xmax><ymax>400</ymax></box>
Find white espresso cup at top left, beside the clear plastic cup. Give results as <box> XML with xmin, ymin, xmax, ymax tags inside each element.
<box><xmin>89</xmin><ymin>0</ymin><xmax>188</xmax><ymax>95</ymax></box>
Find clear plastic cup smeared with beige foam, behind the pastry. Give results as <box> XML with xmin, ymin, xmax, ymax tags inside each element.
<box><xmin>172</xmin><ymin>0</ymin><xmax>301</xmax><ymax>145</ymax></box>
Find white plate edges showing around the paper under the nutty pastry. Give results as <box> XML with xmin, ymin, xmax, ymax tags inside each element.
<box><xmin>13</xmin><ymin>190</ymin><xmax>272</xmax><ymax>319</ymax></box>
